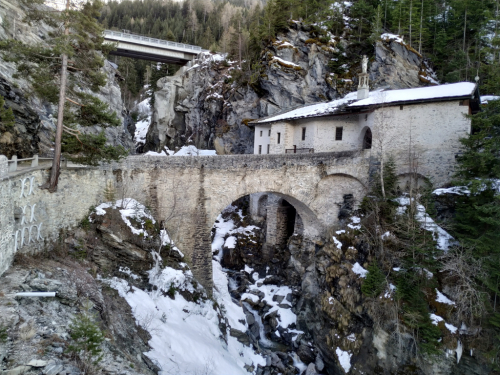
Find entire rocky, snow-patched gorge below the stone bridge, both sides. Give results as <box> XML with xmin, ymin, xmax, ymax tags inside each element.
<box><xmin>0</xmin><ymin>191</ymin><xmax>489</xmax><ymax>375</ymax></box>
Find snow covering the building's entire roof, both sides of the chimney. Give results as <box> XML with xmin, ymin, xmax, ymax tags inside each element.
<box><xmin>251</xmin><ymin>82</ymin><xmax>476</xmax><ymax>124</ymax></box>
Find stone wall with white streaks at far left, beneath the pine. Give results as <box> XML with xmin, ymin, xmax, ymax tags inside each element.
<box><xmin>0</xmin><ymin>168</ymin><xmax>110</xmax><ymax>274</ymax></box>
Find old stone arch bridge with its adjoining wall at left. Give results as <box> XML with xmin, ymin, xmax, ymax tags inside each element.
<box><xmin>0</xmin><ymin>151</ymin><xmax>370</xmax><ymax>292</ymax></box>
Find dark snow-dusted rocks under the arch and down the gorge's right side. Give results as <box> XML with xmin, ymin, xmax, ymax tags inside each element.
<box><xmin>214</xmin><ymin>198</ymin><xmax>490</xmax><ymax>375</ymax></box>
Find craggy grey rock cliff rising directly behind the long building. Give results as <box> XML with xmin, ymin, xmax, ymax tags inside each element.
<box><xmin>144</xmin><ymin>22</ymin><xmax>433</xmax><ymax>155</ymax></box>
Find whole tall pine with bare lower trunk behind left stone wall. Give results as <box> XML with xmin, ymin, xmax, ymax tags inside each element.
<box><xmin>0</xmin><ymin>0</ymin><xmax>127</xmax><ymax>192</ymax></box>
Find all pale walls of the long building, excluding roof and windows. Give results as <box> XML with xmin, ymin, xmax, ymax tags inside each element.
<box><xmin>260</xmin><ymin>100</ymin><xmax>471</xmax><ymax>186</ymax></box>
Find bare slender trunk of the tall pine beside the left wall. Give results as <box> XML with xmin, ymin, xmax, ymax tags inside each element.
<box><xmin>41</xmin><ymin>0</ymin><xmax>69</xmax><ymax>193</ymax></box>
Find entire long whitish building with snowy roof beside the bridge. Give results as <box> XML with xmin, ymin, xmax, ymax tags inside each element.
<box><xmin>250</xmin><ymin>82</ymin><xmax>480</xmax><ymax>184</ymax></box>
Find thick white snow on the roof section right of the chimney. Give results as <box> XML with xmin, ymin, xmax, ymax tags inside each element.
<box><xmin>349</xmin><ymin>82</ymin><xmax>476</xmax><ymax>107</ymax></box>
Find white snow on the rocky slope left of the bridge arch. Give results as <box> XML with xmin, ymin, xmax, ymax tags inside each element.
<box><xmin>96</xmin><ymin>199</ymin><xmax>266</xmax><ymax>375</ymax></box>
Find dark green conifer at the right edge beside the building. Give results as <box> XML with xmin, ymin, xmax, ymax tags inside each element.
<box><xmin>455</xmin><ymin>100</ymin><xmax>500</xmax><ymax>366</ymax></box>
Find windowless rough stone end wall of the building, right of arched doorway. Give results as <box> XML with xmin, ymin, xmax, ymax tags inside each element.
<box><xmin>372</xmin><ymin>100</ymin><xmax>471</xmax><ymax>186</ymax></box>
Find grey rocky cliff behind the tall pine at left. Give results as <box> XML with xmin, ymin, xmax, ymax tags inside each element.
<box><xmin>0</xmin><ymin>0</ymin><xmax>133</xmax><ymax>158</ymax></box>
